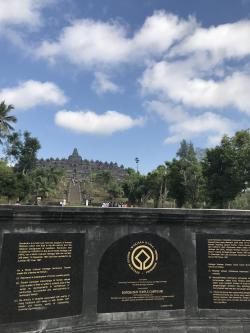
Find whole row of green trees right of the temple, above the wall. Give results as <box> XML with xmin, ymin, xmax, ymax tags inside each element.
<box><xmin>123</xmin><ymin>130</ymin><xmax>250</xmax><ymax>208</ymax></box>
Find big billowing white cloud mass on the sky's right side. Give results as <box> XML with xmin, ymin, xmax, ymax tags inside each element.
<box><xmin>139</xmin><ymin>15</ymin><xmax>250</xmax><ymax>145</ymax></box>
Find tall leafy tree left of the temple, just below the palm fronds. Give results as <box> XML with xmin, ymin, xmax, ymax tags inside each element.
<box><xmin>7</xmin><ymin>131</ymin><xmax>41</xmax><ymax>175</ymax></box>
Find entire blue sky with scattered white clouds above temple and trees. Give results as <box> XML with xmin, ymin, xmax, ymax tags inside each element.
<box><xmin>0</xmin><ymin>0</ymin><xmax>250</xmax><ymax>173</ymax></box>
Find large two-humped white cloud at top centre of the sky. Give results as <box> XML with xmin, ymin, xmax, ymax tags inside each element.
<box><xmin>36</xmin><ymin>11</ymin><xmax>195</xmax><ymax>67</ymax></box>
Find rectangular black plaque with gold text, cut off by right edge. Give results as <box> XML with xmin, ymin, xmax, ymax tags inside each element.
<box><xmin>196</xmin><ymin>234</ymin><xmax>250</xmax><ymax>309</ymax></box>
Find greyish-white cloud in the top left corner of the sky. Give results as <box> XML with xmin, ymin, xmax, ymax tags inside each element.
<box><xmin>0</xmin><ymin>0</ymin><xmax>53</xmax><ymax>26</ymax></box>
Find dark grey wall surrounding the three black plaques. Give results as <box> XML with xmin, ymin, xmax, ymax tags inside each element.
<box><xmin>0</xmin><ymin>206</ymin><xmax>250</xmax><ymax>333</ymax></box>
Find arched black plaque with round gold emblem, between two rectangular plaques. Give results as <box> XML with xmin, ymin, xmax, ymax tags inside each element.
<box><xmin>97</xmin><ymin>233</ymin><xmax>184</xmax><ymax>313</ymax></box>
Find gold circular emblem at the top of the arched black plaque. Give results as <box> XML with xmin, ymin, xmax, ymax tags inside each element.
<box><xmin>127</xmin><ymin>241</ymin><xmax>158</xmax><ymax>274</ymax></box>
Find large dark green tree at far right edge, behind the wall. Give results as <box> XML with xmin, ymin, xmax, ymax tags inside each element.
<box><xmin>203</xmin><ymin>130</ymin><xmax>250</xmax><ymax>208</ymax></box>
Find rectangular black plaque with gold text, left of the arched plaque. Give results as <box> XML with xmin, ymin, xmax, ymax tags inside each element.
<box><xmin>0</xmin><ymin>233</ymin><xmax>84</xmax><ymax>323</ymax></box>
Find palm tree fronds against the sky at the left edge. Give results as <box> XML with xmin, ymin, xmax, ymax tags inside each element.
<box><xmin>0</xmin><ymin>101</ymin><xmax>17</xmax><ymax>143</ymax></box>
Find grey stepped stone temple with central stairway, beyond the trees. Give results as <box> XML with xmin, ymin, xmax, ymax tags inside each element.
<box><xmin>37</xmin><ymin>148</ymin><xmax>127</xmax><ymax>204</ymax></box>
